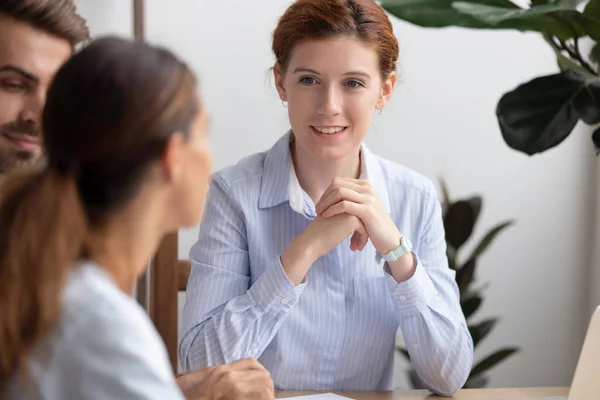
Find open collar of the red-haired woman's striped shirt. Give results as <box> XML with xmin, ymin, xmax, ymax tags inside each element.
<box><xmin>258</xmin><ymin>131</ymin><xmax>390</xmax><ymax>213</ymax></box>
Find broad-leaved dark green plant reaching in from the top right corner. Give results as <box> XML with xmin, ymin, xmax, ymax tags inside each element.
<box><xmin>381</xmin><ymin>0</ymin><xmax>600</xmax><ymax>155</ymax></box>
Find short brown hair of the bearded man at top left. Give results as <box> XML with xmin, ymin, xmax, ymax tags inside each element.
<box><xmin>0</xmin><ymin>0</ymin><xmax>90</xmax><ymax>47</ymax></box>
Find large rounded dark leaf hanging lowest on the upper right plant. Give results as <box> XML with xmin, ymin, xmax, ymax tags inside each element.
<box><xmin>496</xmin><ymin>71</ymin><xmax>600</xmax><ymax>155</ymax></box>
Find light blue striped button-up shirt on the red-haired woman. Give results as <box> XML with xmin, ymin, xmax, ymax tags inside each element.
<box><xmin>179</xmin><ymin>132</ymin><xmax>473</xmax><ymax>395</ymax></box>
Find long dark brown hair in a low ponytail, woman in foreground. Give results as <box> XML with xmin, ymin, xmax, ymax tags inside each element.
<box><xmin>0</xmin><ymin>37</ymin><xmax>199</xmax><ymax>397</ymax></box>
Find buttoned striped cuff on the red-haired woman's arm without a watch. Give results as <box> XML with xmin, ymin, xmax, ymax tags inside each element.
<box><xmin>247</xmin><ymin>257</ymin><xmax>306</xmax><ymax>315</ymax></box>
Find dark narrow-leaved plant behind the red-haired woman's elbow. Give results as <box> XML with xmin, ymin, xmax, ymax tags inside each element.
<box><xmin>397</xmin><ymin>180</ymin><xmax>519</xmax><ymax>389</ymax></box>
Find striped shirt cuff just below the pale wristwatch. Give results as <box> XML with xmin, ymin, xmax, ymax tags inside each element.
<box><xmin>384</xmin><ymin>253</ymin><xmax>437</xmax><ymax>316</ymax></box>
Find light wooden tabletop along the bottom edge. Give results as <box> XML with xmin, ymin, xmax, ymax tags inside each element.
<box><xmin>275</xmin><ymin>387</ymin><xmax>569</xmax><ymax>400</ymax></box>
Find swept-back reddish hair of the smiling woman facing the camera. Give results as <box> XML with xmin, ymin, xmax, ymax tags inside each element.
<box><xmin>272</xmin><ymin>0</ymin><xmax>399</xmax><ymax>79</ymax></box>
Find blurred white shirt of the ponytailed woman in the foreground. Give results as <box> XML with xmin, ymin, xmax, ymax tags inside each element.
<box><xmin>8</xmin><ymin>263</ymin><xmax>183</xmax><ymax>400</ymax></box>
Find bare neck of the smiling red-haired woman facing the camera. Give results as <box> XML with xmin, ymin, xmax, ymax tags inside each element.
<box><xmin>290</xmin><ymin>141</ymin><xmax>361</xmax><ymax>204</ymax></box>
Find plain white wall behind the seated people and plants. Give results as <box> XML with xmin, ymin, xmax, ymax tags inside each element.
<box><xmin>79</xmin><ymin>0</ymin><xmax>596</xmax><ymax>387</ymax></box>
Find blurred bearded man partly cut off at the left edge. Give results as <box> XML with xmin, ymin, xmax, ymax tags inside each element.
<box><xmin>0</xmin><ymin>0</ymin><xmax>89</xmax><ymax>179</ymax></box>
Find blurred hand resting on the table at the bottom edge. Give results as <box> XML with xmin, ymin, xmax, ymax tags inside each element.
<box><xmin>177</xmin><ymin>358</ymin><xmax>275</xmax><ymax>400</ymax></box>
